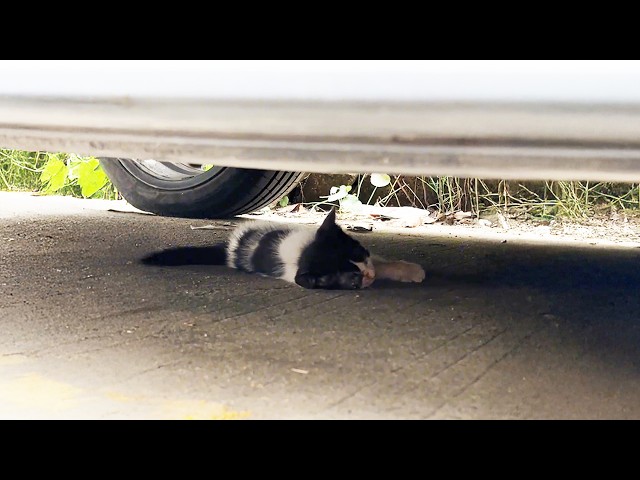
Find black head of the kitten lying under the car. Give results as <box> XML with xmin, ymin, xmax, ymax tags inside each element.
<box><xmin>296</xmin><ymin>210</ymin><xmax>375</xmax><ymax>289</ymax></box>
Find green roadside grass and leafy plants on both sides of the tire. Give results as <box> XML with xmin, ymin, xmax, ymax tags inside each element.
<box><xmin>0</xmin><ymin>149</ymin><xmax>640</xmax><ymax>220</ymax></box>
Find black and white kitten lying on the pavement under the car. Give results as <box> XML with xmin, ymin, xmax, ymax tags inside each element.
<box><xmin>142</xmin><ymin>210</ymin><xmax>424</xmax><ymax>290</ymax></box>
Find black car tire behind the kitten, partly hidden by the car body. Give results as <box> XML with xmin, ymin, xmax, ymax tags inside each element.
<box><xmin>100</xmin><ymin>158</ymin><xmax>304</xmax><ymax>218</ymax></box>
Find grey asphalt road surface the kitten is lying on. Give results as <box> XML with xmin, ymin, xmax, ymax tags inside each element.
<box><xmin>0</xmin><ymin>194</ymin><xmax>640</xmax><ymax>419</ymax></box>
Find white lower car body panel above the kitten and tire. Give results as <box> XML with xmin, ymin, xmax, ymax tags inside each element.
<box><xmin>0</xmin><ymin>61</ymin><xmax>640</xmax><ymax>182</ymax></box>
